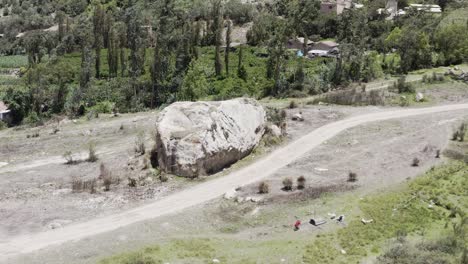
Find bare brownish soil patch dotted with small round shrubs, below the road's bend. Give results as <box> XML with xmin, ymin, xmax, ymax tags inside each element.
<box><xmin>232</xmin><ymin>110</ymin><xmax>463</xmax><ymax>203</ymax></box>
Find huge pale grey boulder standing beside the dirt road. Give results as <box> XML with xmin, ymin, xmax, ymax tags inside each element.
<box><xmin>156</xmin><ymin>98</ymin><xmax>266</xmax><ymax>177</ymax></box>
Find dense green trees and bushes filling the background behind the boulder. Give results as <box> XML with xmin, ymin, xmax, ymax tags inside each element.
<box><xmin>0</xmin><ymin>0</ymin><xmax>468</xmax><ymax>124</ymax></box>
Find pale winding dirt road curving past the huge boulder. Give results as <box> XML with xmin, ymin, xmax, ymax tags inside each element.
<box><xmin>0</xmin><ymin>104</ymin><xmax>468</xmax><ymax>260</ymax></box>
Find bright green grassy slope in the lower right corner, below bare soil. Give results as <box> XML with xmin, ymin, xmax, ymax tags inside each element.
<box><xmin>304</xmin><ymin>162</ymin><xmax>468</xmax><ymax>264</ymax></box>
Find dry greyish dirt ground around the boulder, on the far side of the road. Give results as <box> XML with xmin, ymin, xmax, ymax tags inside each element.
<box><xmin>0</xmin><ymin>106</ymin><xmax>379</xmax><ymax>242</ymax></box>
